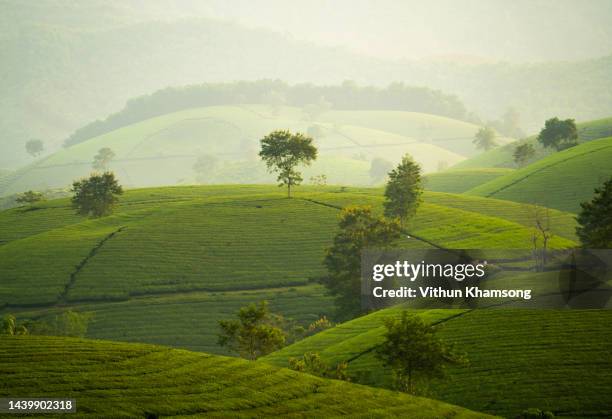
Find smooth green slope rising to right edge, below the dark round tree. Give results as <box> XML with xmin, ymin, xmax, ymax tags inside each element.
<box><xmin>466</xmin><ymin>137</ymin><xmax>612</xmax><ymax>212</ymax></box>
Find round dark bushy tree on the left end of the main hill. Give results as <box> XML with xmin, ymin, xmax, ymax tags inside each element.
<box><xmin>72</xmin><ymin>172</ymin><xmax>123</xmax><ymax>217</ymax></box>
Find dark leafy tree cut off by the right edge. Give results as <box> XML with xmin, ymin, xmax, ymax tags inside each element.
<box><xmin>576</xmin><ymin>177</ymin><xmax>612</xmax><ymax>249</ymax></box>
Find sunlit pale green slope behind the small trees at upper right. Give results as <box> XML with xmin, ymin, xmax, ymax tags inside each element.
<box><xmin>453</xmin><ymin>118</ymin><xmax>612</xmax><ymax>169</ymax></box>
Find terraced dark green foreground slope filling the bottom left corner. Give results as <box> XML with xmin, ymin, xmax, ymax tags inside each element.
<box><xmin>0</xmin><ymin>337</ymin><xmax>484</xmax><ymax>418</ymax></box>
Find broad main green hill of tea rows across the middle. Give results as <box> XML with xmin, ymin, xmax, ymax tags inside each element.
<box><xmin>0</xmin><ymin>185</ymin><xmax>575</xmax><ymax>353</ymax></box>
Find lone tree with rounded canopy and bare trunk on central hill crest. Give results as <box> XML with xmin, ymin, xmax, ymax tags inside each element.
<box><xmin>259</xmin><ymin>131</ymin><xmax>317</xmax><ymax>198</ymax></box>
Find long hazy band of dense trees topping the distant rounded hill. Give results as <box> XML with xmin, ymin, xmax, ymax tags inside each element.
<box><xmin>64</xmin><ymin>80</ymin><xmax>468</xmax><ymax>146</ymax></box>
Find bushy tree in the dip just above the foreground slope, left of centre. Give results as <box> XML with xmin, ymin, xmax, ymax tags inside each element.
<box><xmin>218</xmin><ymin>301</ymin><xmax>285</xmax><ymax>360</ymax></box>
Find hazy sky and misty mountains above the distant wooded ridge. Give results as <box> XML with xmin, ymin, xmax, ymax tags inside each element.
<box><xmin>0</xmin><ymin>0</ymin><xmax>612</xmax><ymax>168</ymax></box>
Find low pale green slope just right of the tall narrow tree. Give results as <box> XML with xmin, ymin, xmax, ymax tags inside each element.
<box><xmin>423</xmin><ymin>168</ymin><xmax>512</xmax><ymax>193</ymax></box>
